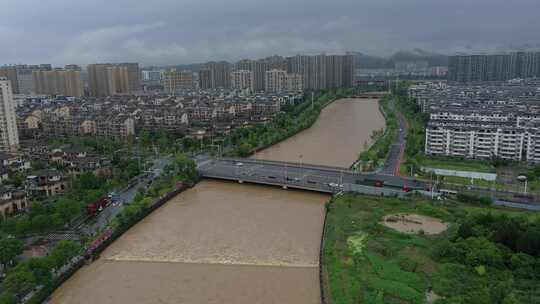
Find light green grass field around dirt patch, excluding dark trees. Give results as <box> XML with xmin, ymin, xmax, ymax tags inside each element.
<box><xmin>322</xmin><ymin>194</ymin><xmax>540</xmax><ymax>304</ymax></box>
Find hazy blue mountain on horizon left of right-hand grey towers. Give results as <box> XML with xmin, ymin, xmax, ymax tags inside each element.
<box><xmin>356</xmin><ymin>49</ymin><xmax>448</xmax><ymax>69</ymax></box>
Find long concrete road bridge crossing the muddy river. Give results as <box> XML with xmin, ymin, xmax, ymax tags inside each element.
<box><xmin>198</xmin><ymin>158</ymin><xmax>426</xmax><ymax>193</ymax></box>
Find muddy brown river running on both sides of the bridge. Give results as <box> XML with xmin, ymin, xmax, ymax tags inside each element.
<box><xmin>52</xmin><ymin>99</ymin><xmax>384</xmax><ymax>304</ymax></box>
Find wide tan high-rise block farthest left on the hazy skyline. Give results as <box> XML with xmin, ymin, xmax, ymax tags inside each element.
<box><xmin>32</xmin><ymin>65</ymin><xmax>84</xmax><ymax>97</ymax></box>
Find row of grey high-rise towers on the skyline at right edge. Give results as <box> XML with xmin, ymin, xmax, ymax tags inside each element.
<box><xmin>448</xmin><ymin>52</ymin><xmax>540</xmax><ymax>82</ymax></box>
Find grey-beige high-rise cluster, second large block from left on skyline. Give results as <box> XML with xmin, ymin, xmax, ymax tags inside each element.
<box><xmin>87</xmin><ymin>63</ymin><xmax>140</xmax><ymax>96</ymax></box>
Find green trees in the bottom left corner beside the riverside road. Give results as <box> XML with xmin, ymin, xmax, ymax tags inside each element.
<box><xmin>0</xmin><ymin>241</ymin><xmax>82</xmax><ymax>304</ymax></box>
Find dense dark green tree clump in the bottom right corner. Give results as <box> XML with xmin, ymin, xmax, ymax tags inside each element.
<box><xmin>433</xmin><ymin>212</ymin><xmax>540</xmax><ymax>304</ymax></box>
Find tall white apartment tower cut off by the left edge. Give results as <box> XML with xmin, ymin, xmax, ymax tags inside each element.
<box><xmin>0</xmin><ymin>77</ymin><xmax>19</xmax><ymax>152</ymax></box>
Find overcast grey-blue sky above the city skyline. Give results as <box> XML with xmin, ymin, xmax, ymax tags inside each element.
<box><xmin>0</xmin><ymin>0</ymin><xmax>540</xmax><ymax>65</ymax></box>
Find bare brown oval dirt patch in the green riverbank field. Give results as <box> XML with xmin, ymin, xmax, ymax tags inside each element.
<box><xmin>381</xmin><ymin>213</ymin><xmax>448</xmax><ymax>234</ymax></box>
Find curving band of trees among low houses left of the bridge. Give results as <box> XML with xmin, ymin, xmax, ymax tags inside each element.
<box><xmin>0</xmin><ymin>136</ymin><xmax>151</xmax><ymax>236</ymax></box>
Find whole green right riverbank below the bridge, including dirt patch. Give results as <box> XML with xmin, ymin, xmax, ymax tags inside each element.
<box><xmin>321</xmin><ymin>194</ymin><xmax>540</xmax><ymax>303</ymax></box>
